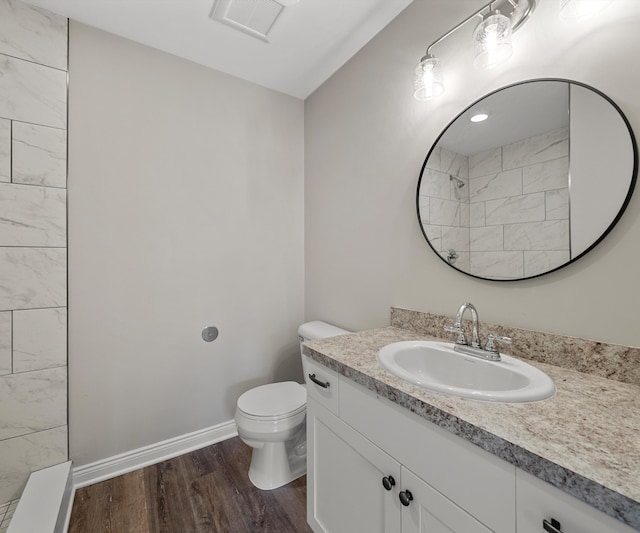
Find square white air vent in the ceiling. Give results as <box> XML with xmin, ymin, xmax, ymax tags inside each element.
<box><xmin>209</xmin><ymin>0</ymin><xmax>297</xmax><ymax>43</ymax></box>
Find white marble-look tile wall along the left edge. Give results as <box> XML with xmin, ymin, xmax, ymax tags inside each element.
<box><xmin>0</xmin><ymin>0</ymin><xmax>68</xmax><ymax>508</ymax></box>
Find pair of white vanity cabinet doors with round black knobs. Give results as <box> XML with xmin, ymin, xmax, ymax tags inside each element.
<box><xmin>307</xmin><ymin>400</ymin><xmax>491</xmax><ymax>533</ymax></box>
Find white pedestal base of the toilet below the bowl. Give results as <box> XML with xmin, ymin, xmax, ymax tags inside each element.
<box><xmin>249</xmin><ymin>442</ymin><xmax>307</xmax><ymax>490</ymax></box>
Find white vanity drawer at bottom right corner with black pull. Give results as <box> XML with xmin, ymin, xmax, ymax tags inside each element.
<box><xmin>516</xmin><ymin>468</ymin><xmax>637</xmax><ymax>533</ymax></box>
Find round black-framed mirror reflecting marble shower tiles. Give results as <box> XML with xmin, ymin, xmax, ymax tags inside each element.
<box><xmin>417</xmin><ymin>79</ymin><xmax>638</xmax><ymax>281</ymax></box>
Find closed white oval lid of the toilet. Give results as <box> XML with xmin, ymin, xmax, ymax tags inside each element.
<box><xmin>238</xmin><ymin>381</ymin><xmax>307</xmax><ymax>417</ymax></box>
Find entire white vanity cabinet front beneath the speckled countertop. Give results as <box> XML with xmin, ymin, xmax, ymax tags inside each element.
<box><xmin>305</xmin><ymin>357</ymin><xmax>636</xmax><ymax>533</ymax></box>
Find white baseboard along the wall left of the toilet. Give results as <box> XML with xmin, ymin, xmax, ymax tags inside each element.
<box><xmin>73</xmin><ymin>420</ymin><xmax>238</xmax><ymax>489</ymax></box>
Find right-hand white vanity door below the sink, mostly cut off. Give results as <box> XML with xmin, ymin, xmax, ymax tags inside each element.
<box><xmin>400</xmin><ymin>467</ymin><xmax>492</xmax><ymax>533</ymax></box>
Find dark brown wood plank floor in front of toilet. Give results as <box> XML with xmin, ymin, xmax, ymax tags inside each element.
<box><xmin>69</xmin><ymin>437</ymin><xmax>311</xmax><ymax>533</ymax></box>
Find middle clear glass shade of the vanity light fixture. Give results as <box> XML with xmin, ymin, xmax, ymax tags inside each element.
<box><xmin>473</xmin><ymin>10</ymin><xmax>513</xmax><ymax>68</ymax></box>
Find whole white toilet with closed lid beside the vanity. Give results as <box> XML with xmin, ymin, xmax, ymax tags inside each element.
<box><xmin>235</xmin><ymin>321</ymin><xmax>349</xmax><ymax>490</ymax></box>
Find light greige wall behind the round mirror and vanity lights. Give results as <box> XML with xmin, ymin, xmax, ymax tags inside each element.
<box><xmin>305</xmin><ymin>0</ymin><xmax>640</xmax><ymax>346</ymax></box>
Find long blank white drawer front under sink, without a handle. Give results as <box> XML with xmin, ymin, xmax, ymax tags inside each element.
<box><xmin>340</xmin><ymin>377</ymin><xmax>516</xmax><ymax>533</ymax></box>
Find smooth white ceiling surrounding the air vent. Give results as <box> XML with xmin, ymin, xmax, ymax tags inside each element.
<box><xmin>25</xmin><ymin>0</ymin><xmax>413</xmax><ymax>99</ymax></box>
